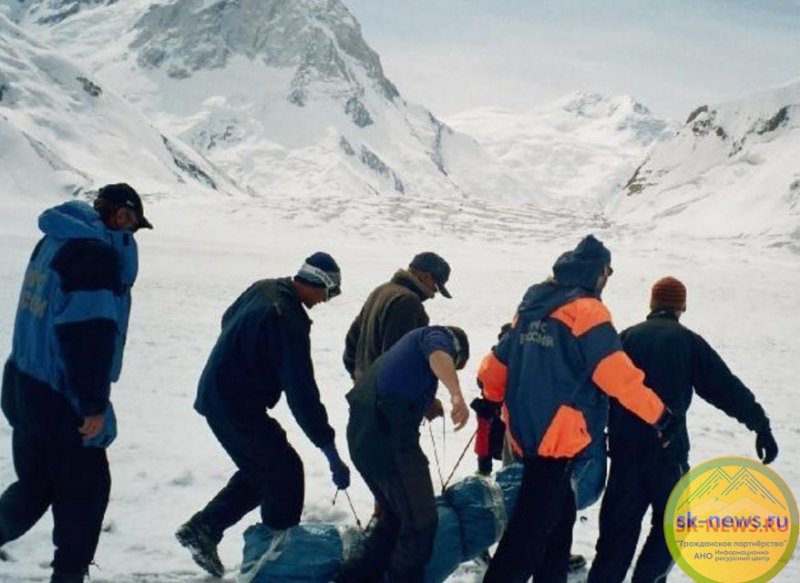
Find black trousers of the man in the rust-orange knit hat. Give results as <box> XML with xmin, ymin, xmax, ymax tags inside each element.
<box><xmin>587</xmin><ymin>460</ymin><xmax>689</xmax><ymax>583</ymax></box>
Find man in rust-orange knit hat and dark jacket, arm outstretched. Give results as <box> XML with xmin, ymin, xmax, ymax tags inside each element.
<box><xmin>588</xmin><ymin>277</ymin><xmax>778</xmax><ymax>583</ymax></box>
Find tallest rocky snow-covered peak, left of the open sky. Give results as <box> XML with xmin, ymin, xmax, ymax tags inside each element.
<box><xmin>5</xmin><ymin>0</ymin><xmax>530</xmax><ymax>203</ymax></box>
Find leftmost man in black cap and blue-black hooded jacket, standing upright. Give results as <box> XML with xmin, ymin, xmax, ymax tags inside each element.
<box><xmin>0</xmin><ymin>184</ymin><xmax>152</xmax><ymax>583</ymax></box>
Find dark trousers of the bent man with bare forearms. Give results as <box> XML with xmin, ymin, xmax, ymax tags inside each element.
<box><xmin>336</xmin><ymin>392</ymin><xmax>438</xmax><ymax>583</ymax></box>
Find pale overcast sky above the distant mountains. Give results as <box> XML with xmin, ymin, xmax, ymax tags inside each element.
<box><xmin>344</xmin><ymin>0</ymin><xmax>800</xmax><ymax>121</ymax></box>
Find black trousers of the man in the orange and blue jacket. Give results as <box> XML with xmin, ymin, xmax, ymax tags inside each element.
<box><xmin>483</xmin><ymin>457</ymin><xmax>576</xmax><ymax>583</ymax></box>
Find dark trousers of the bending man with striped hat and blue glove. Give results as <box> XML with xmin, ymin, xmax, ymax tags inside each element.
<box><xmin>191</xmin><ymin>415</ymin><xmax>305</xmax><ymax>542</ymax></box>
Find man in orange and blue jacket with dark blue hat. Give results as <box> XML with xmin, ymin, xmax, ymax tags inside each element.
<box><xmin>479</xmin><ymin>235</ymin><xmax>675</xmax><ymax>583</ymax></box>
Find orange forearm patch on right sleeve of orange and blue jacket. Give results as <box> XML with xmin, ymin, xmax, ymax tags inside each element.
<box><xmin>592</xmin><ymin>350</ymin><xmax>664</xmax><ymax>425</ymax></box>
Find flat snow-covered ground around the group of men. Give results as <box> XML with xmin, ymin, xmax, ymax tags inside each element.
<box><xmin>0</xmin><ymin>197</ymin><xmax>800</xmax><ymax>583</ymax></box>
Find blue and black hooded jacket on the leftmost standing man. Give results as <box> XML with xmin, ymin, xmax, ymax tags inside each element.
<box><xmin>6</xmin><ymin>201</ymin><xmax>138</xmax><ymax>446</ymax></box>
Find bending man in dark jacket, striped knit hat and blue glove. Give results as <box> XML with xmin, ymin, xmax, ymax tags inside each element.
<box><xmin>175</xmin><ymin>252</ymin><xmax>350</xmax><ymax>577</ymax></box>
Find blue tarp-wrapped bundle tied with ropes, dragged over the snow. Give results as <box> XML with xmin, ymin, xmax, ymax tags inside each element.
<box><xmin>239</xmin><ymin>464</ymin><xmax>592</xmax><ymax>583</ymax></box>
